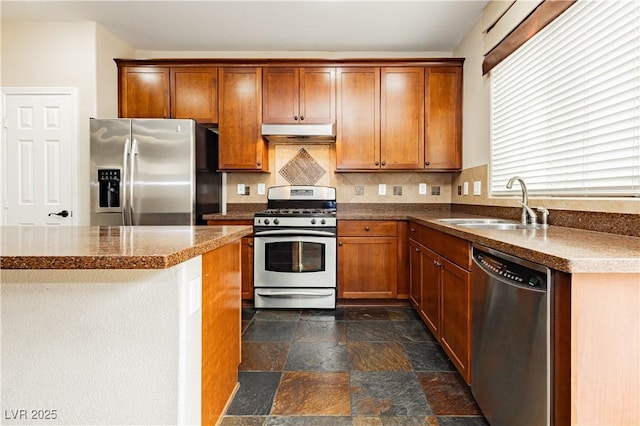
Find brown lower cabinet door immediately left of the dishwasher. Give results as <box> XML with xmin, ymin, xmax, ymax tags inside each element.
<box><xmin>440</xmin><ymin>259</ymin><xmax>471</xmax><ymax>383</ymax></box>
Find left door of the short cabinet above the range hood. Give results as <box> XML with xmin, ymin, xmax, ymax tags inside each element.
<box><xmin>262</xmin><ymin>67</ymin><xmax>300</xmax><ymax>124</ymax></box>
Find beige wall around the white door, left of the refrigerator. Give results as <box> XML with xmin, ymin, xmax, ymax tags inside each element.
<box><xmin>0</xmin><ymin>22</ymin><xmax>133</xmax><ymax>225</ymax></box>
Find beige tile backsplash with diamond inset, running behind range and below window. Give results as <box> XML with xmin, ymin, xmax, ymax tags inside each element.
<box><xmin>227</xmin><ymin>148</ymin><xmax>640</xmax><ymax>214</ymax></box>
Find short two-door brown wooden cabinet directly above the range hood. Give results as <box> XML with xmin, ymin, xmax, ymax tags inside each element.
<box><xmin>262</xmin><ymin>67</ymin><xmax>336</xmax><ymax>124</ymax></box>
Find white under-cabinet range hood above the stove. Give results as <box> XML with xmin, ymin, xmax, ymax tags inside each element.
<box><xmin>262</xmin><ymin>123</ymin><xmax>336</xmax><ymax>143</ymax></box>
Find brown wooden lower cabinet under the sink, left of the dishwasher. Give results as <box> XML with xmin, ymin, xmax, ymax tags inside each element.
<box><xmin>409</xmin><ymin>222</ymin><xmax>471</xmax><ymax>384</ymax></box>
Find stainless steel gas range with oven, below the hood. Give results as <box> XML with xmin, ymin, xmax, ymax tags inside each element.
<box><xmin>253</xmin><ymin>186</ymin><xmax>337</xmax><ymax>309</ymax></box>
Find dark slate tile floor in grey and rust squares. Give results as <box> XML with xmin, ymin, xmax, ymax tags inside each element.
<box><xmin>222</xmin><ymin>307</ymin><xmax>488</xmax><ymax>426</ymax></box>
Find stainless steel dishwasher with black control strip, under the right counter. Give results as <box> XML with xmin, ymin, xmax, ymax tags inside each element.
<box><xmin>471</xmin><ymin>245</ymin><xmax>552</xmax><ymax>426</ymax></box>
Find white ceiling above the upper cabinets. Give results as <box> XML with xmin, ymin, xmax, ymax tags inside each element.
<box><xmin>0</xmin><ymin>0</ymin><xmax>487</xmax><ymax>52</ymax></box>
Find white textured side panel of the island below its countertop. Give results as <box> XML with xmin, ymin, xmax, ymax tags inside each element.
<box><xmin>0</xmin><ymin>256</ymin><xmax>202</xmax><ymax>424</ymax></box>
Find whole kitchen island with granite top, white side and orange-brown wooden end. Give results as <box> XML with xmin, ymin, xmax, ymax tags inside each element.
<box><xmin>0</xmin><ymin>226</ymin><xmax>251</xmax><ymax>424</ymax></box>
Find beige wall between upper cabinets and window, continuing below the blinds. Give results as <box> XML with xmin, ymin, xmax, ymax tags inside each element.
<box><xmin>451</xmin><ymin>9</ymin><xmax>640</xmax><ymax>214</ymax></box>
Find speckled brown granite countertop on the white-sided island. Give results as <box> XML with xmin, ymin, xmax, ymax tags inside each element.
<box><xmin>0</xmin><ymin>226</ymin><xmax>252</xmax><ymax>269</ymax></box>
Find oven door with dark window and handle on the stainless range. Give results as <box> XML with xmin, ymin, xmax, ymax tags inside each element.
<box><xmin>253</xmin><ymin>229</ymin><xmax>336</xmax><ymax>289</ymax></box>
